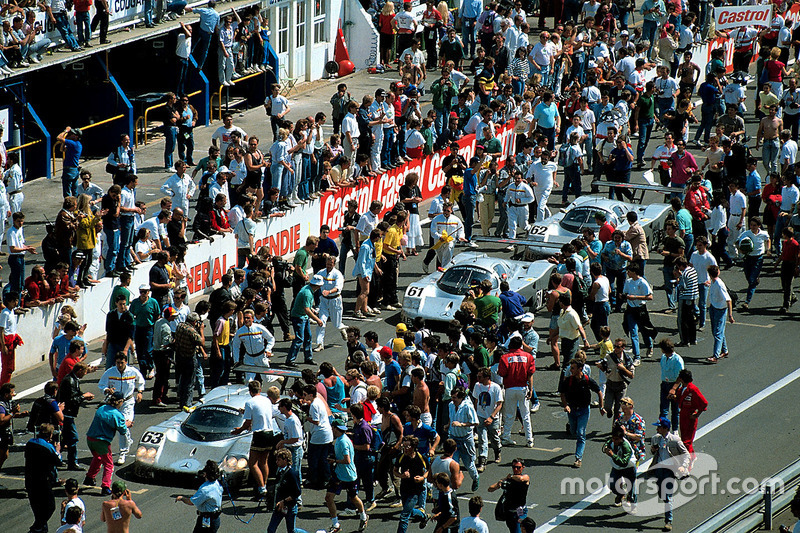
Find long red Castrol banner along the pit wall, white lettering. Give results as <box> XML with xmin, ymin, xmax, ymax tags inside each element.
<box><xmin>319</xmin><ymin>120</ymin><xmax>515</xmax><ymax>238</ymax></box>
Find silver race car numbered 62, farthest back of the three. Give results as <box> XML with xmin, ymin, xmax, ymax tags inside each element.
<box><xmin>514</xmin><ymin>196</ymin><xmax>671</xmax><ymax>260</ymax></box>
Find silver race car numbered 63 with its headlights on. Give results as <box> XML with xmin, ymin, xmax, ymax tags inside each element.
<box><xmin>138</xmin><ymin>382</ymin><xmax>281</xmax><ymax>486</ymax></box>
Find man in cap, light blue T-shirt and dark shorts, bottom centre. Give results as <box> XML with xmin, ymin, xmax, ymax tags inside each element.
<box><xmin>325</xmin><ymin>418</ymin><xmax>369</xmax><ymax>533</ymax></box>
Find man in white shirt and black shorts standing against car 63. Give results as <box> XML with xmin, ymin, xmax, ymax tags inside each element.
<box><xmin>231</xmin><ymin>381</ymin><xmax>280</xmax><ymax>496</ymax></box>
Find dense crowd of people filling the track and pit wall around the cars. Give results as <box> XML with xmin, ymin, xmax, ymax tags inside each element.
<box><xmin>0</xmin><ymin>0</ymin><xmax>800</xmax><ymax>533</ymax></box>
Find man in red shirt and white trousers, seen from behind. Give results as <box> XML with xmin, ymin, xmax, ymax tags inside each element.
<box><xmin>497</xmin><ymin>336</ymin><xmax>536</xmax><ymax>448</ymax></box>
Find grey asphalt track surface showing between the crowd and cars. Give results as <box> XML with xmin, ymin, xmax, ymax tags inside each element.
<box><xmin>0</xmin><ymin>65</ymin><xmax>800</xmax><ymax>533</ymax></box>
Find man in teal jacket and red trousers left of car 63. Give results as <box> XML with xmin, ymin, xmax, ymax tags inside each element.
<box><xmin>83</xmin><ymin>391</ymin><xmax>133</xmax><ymax>496</ymax></box>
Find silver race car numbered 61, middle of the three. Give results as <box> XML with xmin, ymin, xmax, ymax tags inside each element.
<box><xmin>402</xmin><ymin>252</ymin><xmax>555</xmax><ymax>323</ymax></box>
